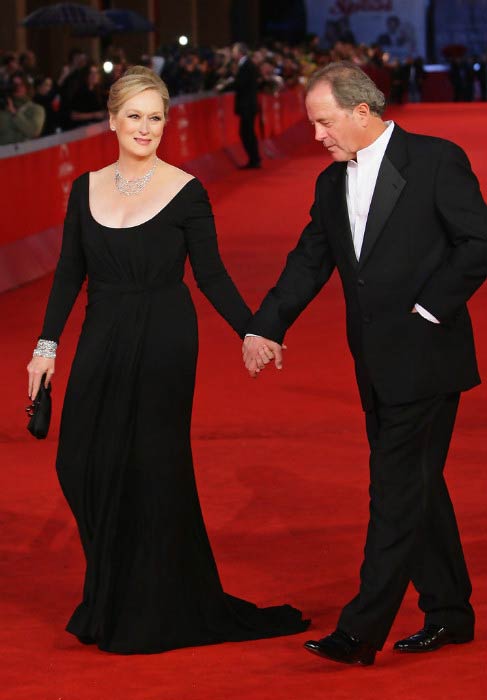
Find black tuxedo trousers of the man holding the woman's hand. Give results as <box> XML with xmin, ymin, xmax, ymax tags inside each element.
<box><xmin>338</xmin><ymin>393</ymin><xmax>474</xmax><ymax>649</ymax></box>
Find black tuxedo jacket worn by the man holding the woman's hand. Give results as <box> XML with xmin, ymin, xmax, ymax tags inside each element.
<box><xmin>247</xmin><ymin>125</ymin><xmax>487</xmax><ymax>409</ymax></box>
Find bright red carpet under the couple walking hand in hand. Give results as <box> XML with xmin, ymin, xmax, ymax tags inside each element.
<box><xmin>0</xmin><ymin>104</ymin><xmax>487</xmax><ymax>700</ymax></box>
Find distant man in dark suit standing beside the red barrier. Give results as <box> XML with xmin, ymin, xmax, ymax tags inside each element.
<box><xmin>232</xmin><ymin>42</ymin><xmax>260</xmax><ymax>168</ymax></box>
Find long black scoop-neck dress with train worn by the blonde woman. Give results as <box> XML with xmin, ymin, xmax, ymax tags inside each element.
<box><xmin>41</xmin><ymin>173</ymin><xmax>308</xmax><ymax>653</ymax></box>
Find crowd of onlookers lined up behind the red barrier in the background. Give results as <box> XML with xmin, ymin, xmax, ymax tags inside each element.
<box><xmin>0</xmin><ymin>37</ymin><xmax>487</xmax><ymax>145</ymax></box>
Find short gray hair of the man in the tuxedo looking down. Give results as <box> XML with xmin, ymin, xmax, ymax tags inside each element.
<box><xmin>306</xmin><ymin>61</ymin><xmax>386</xmax><ymax>116</ymax></box>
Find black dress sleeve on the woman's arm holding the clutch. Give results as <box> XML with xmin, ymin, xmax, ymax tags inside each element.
<box><xmin>41</xmin><ymin>180</ymin><xmax>86</xmax><ymax>342</ymax></box>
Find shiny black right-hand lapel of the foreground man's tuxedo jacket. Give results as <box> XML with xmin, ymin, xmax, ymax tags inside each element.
<box><xmin>359</xmin><ymin>125</ymin><xmax>408</xmax><ymax>267</ymax></box>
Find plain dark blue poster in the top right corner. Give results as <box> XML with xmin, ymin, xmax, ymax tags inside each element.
<box><xmin>435</xmin><ymin>0</ymin><xmax>487</xmax><ymax>60</ymax></box>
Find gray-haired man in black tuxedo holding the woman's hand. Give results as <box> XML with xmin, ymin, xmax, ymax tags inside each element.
<box><xmin>243</xmin><ymin>62</ymin><xmax>487</xmax><ymax>665</ymax></box>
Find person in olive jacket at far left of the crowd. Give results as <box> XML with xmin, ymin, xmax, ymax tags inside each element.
<box><xmin>0</xmin><ymin>73</ymin><xmax>46</xmax><ymax>145</ymax></box>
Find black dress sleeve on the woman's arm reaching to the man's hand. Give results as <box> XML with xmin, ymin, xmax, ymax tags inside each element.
<box><xmin>184</xmin><ymin>183</ymin><xmax>252</xmax><ymax>338</ymax></box>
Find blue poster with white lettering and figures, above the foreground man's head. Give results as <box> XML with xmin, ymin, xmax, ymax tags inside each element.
<box><xmin>306</xmin><ymin>0</ymin><xmax>427</xmax><ymax>59</ymax></box>
